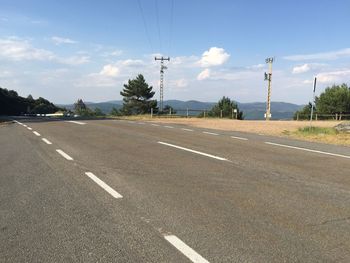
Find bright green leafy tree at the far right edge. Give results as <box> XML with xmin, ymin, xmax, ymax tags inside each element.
<box><xmin>315</xmin><ymin>84</ymin><xmax>350</xmax><ymax>114</ymax></box>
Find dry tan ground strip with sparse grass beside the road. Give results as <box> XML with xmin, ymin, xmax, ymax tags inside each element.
<box><xmin>119</xmin><ymin>115</ymin><xmax>350</xmax><ymax>146</ymax></box>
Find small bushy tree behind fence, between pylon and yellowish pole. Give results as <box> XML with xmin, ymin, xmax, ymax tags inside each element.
<box><xmin>208</xmin><ymin>96</ymin><xmax>243</xmax><ymax>120</ymax></box>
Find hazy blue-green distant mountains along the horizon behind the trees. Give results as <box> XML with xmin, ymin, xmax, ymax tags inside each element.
<box><xmin>58</xmin><ymin>100</ymin><xmax>304</xmax><ymax>120</ymax></box>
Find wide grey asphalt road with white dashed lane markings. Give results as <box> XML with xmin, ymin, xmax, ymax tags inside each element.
<box><xmin>0</xmin><ymin>119</ymin><xmax>350</xmax><ymax>262</ymax></box>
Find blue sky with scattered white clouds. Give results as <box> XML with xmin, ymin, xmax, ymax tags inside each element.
<box><xmin>0</xmin><ymin>0</ymin><xmax>350</xmax><ymax>104</ymax></box>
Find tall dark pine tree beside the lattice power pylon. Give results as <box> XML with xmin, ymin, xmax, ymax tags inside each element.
<box><xmin>120</xmin><ymin>74</ymin><xmax>157</xmax><ymax>115</ymax></box>
